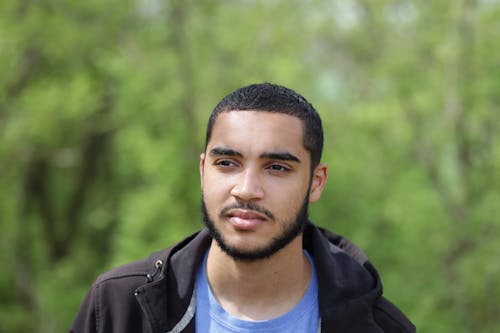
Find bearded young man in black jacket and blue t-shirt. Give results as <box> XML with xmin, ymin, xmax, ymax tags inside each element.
<box><xmin>71</xmin><ymin>83</ymin><xmax>415</xmax><ymax>333</ymax></box>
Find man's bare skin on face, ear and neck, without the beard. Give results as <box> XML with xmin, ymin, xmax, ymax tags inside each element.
<box><xmin>200</xmin><ymin>111</ymin><xmax>327</xmax><ymax>320</ymax></box>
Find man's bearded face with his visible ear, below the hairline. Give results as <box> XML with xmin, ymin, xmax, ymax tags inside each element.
<box><xmin>200</xmin><ymin>111</ymin><xmax>326</xmax><ymax>260</ymax></box>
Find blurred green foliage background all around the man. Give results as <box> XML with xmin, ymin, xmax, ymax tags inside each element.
<box><xmin>0</xmin><ymin>0</ymin><xmax>500</xmax><ymax>333</ymax></box>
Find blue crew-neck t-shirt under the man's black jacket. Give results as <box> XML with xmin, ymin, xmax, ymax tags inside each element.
<box><xmin>195</xmin><ymin>251</ymin><xmax>320</xmax><ymax>333</ymax></box>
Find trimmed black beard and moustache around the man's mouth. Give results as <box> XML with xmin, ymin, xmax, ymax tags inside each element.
<box><xmin>201</xmin><ymin>191</ymin><xmax>309</xmax><ymax>262</ymax></box>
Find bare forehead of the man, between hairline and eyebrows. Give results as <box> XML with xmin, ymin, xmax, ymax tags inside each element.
<box><xmin>207</xmin><ymin>111</ymin><xmax>307</xmax><ymax>154</ymax></box>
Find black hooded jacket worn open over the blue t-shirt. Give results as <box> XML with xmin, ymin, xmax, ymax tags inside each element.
<box><xmin>70</xmin><ymin>224</ymin><xmax>415</xmax><ymax>333</ymax></box>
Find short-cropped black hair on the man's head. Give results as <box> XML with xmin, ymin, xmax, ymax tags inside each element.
<box><xmin>205</xmin><ymin>83</ymin><xmax>323</xmax><ymax>170</ymax></box>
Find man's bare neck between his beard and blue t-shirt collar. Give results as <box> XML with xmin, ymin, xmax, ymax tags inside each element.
<box><xmin>206</xmin><ymin>236</ymin><xmax>312</xmax><ymax>320</ymax></box>
